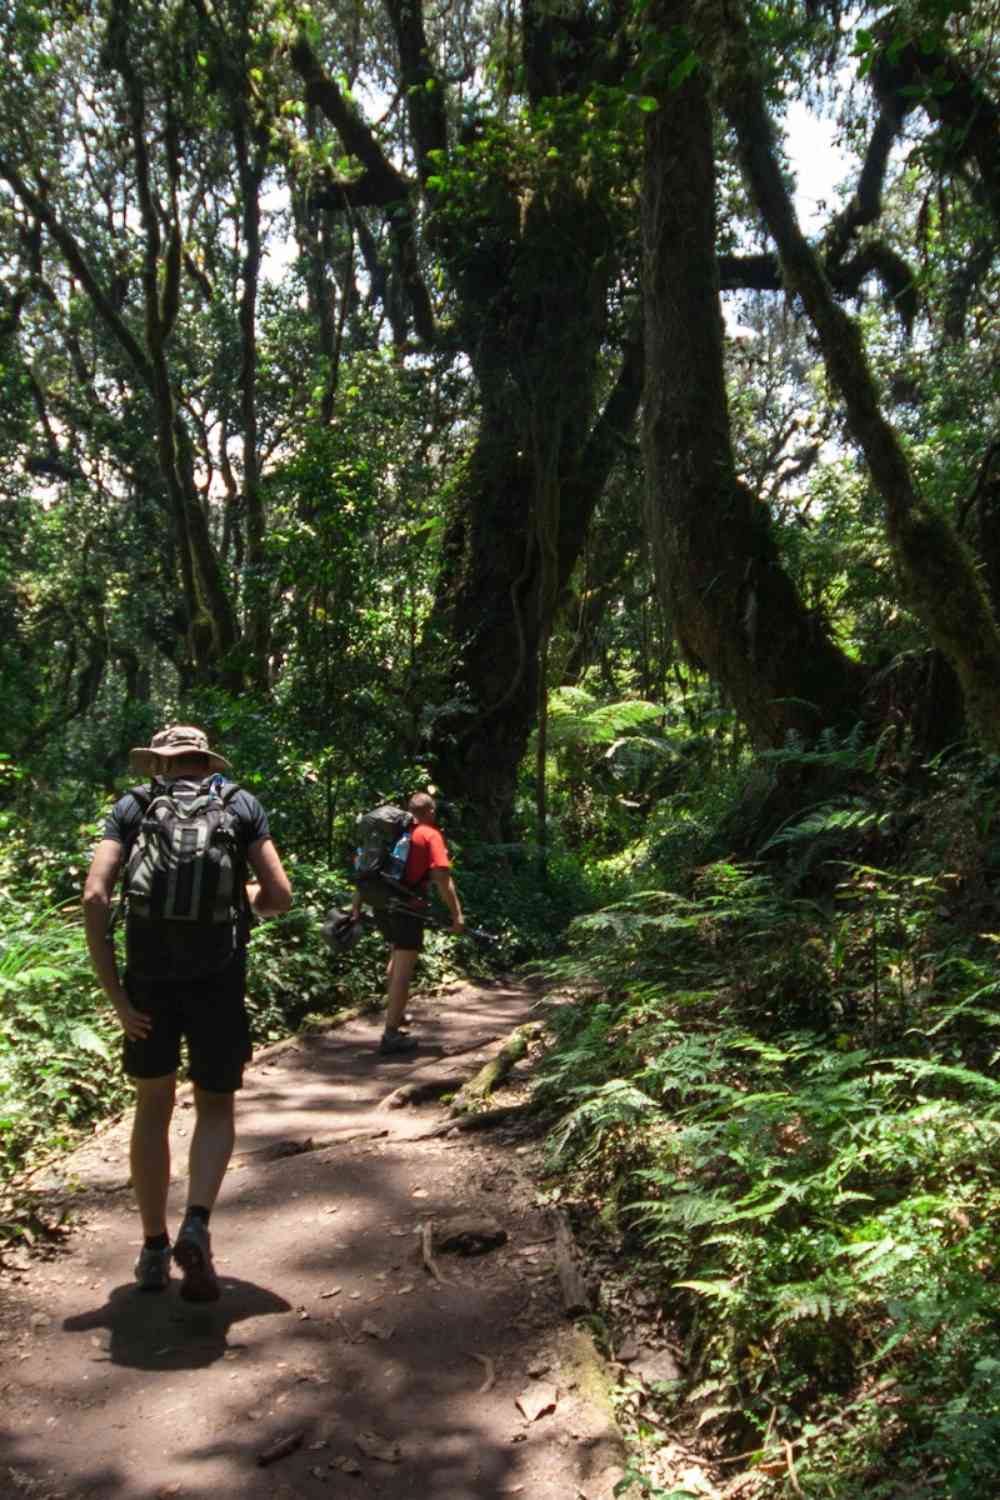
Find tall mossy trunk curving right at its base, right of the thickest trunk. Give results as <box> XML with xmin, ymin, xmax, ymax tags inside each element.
<box><xmin>643</xmin><ymin>0</ymin><xmax>862</xmax><ymax>746</ymax></box>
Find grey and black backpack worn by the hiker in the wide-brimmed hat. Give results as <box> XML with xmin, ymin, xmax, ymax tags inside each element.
<box><xmin>123</xmin><ymin>774</ymin><xmax>247</xmax><ymax>980</ymax></box>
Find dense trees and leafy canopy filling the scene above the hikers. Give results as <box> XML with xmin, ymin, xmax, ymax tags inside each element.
<box><xmin>0</xmin><ymin>0</ymin><xmax>1000</xmax><ymax>839</ymax></box>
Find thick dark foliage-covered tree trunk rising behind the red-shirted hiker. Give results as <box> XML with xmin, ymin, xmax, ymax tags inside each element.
<box><xmin>419</xmin><ymin>178</ymin><xmax>626</xmax><ymax>840</ymax></box>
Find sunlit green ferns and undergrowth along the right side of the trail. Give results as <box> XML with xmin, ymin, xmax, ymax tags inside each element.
<box><xmin>540</xmin><ymin>767</ymin><xmax>1000</xmax><ymax>1500</ymax></box>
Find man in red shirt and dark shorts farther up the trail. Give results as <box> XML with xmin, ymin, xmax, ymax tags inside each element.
<box><xmin>351</xmin><ymin>792</ymin><xmax>465</xmax><ymax>1056</ymax></box>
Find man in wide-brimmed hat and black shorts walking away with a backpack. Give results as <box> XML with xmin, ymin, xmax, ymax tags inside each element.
<box><xmin>84</xmin><ymin>725</ymin><xmax>291</xmax><ymax>1302</ymax></box>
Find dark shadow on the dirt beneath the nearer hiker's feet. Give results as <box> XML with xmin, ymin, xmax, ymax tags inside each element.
<box><xmin>63</xmin><ymin>1277</ymin><xmax>291</xmax><ymax>1373</ymax></box>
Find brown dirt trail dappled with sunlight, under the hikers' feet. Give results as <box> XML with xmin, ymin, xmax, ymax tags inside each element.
<box><xmin>0</xmin><ymin>986</ymin><xmax>621</xmax><ymax>1500</ymax></box>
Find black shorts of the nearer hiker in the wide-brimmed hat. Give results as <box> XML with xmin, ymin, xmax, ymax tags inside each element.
<box><xmin>123</xmin><ymin>948</ymin><xmax>253</xmax><ymax>1094</ymax></box>
